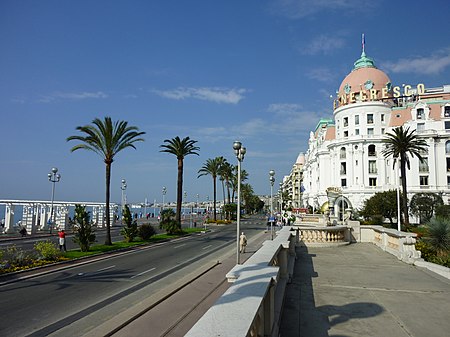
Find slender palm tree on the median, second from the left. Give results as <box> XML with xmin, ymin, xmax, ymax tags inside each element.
<box><xmin>160</xmin><ymin>136</ymin><xmax>200</xmax><ymax>228</ymax></box>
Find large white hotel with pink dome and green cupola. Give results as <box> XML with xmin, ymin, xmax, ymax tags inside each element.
<box><xmin>296</xmin><ymin>50</ymin><xmax>450</xmax><ymax>217</ymax></box>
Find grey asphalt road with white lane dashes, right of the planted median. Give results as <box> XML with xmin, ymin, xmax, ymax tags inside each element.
<box><xmin>0</xmin><ymin>217</ymin><xmax>265</xmax><ymax>336</ymax></box>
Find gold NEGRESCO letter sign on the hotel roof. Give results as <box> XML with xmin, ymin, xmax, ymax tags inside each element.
<box><xmin>333</xmin><ymin>80</ymin><xmax>425</xmax><ymax>109</ymax></box>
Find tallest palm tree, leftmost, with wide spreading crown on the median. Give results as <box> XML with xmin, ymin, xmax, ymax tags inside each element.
<box><xmin>67</xmin><ymin>117</ymin><xmax>145</xmax><ymax>245</ymax></box>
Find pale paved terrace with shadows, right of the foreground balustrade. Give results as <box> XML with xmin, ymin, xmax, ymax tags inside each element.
<box><xmin>280</xmin><ymin>243</ymin><xmax>450</xmax><ymax>337</ymax></box>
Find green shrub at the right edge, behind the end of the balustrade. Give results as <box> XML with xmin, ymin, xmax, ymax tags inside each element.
<box><xmin>424</xmin><ymin>217</ymin><xmax>450</xmax><ymax>257</ymax></box>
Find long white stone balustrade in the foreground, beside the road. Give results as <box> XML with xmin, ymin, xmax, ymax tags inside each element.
<box><xmin>185</xmin><ymin>226</ymin><xmax>297</xmax><ymax>337</ymax></box>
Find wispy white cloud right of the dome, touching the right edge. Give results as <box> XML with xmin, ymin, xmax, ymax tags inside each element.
<box><xmin>383</xmin><ymin>49</ymin><xmax>450</xmax><ymax>75</ymax></box>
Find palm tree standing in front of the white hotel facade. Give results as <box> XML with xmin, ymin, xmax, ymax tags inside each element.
<box><xmin>382</xmin><ymin>126</ymin><xmax>428</xmax><ymax>227</ymax></box>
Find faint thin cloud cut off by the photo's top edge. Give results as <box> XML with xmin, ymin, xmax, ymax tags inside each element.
<box><xmin>271</xmin><ymin>0</ymin><xmax>375</xmax><ymax>19</ymax></box>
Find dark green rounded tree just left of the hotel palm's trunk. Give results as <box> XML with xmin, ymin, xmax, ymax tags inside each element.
<box><xmin>359</xmin><ymin>190</ymin><xmax>398</xmax><ymax>226</ymax></box>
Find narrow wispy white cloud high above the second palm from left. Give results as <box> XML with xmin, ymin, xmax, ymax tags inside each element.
<box><xmin>152</xmin><ymin>87</ymin><xmax>248</xmax><ymax>104</ymax></box>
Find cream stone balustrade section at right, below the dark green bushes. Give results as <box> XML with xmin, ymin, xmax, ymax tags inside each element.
<box><xmin>359</xmin><ymin>226</ymin><xmax>421</xmax><ymax>264</ymax></box>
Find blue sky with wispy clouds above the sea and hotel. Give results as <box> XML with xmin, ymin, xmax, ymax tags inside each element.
<box><xmin>0</xmin><ymin>0</ymin><xmax>450</xmax><ymax>203</ymax></box>
